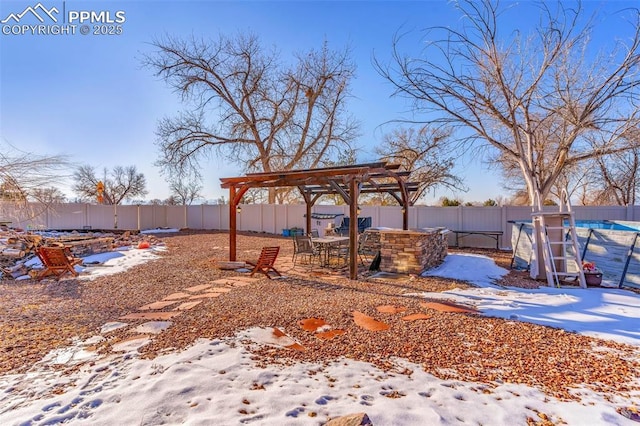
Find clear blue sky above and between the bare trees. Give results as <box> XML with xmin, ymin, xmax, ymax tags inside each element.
<box><xmin>0</xmin><ymin>0</ymin><xmax>635</xmax><ymax>203</ymax></box>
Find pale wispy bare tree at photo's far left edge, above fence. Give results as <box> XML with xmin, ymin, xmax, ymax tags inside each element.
<box><xmin>0</xmin><ymin>142</ymin><xmax>70</xmax><ymax>204</ymax></box>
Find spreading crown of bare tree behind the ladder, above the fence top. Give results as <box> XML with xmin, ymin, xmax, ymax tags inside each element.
<box><xmin>376</xmin><ymin>0</ymin><xmax>640</xmax><ymax>204</ymax></box>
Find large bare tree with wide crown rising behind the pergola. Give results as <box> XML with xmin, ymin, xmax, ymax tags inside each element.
<box><xmin>144</xmin><ymin>34</ymin><xmax>358</xmax><ymax>203</ymax></box>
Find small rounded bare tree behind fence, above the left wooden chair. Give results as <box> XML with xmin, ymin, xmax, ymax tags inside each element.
<box><xmin>73</xmin><ymin>165</ymin><xmax>147</xmax><ymax>205</ymax></box>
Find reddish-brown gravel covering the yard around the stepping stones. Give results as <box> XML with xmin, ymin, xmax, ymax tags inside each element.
<box><xmin>0</xmin><ymin>232</ymin><xmax>640</xmax><ymax>399</ymax></box>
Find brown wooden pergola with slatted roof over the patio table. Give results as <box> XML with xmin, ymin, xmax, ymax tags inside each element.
<box><xmin>220</xmin><ymin>162</ymin><xmax>418</xmax><ymax>280</ymax></box>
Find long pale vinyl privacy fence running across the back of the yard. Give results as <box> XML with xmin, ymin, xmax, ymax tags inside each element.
<box><xmin>0</xmin><ymin>203</ymin><xmax>640</xmax><ymax>249</ymax></box>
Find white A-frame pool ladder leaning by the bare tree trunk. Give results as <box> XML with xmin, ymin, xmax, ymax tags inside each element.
<box><xmin>532</xmin><ymin>191</ymin><xmax>587</xmax><ymax>288</ymax></box>
